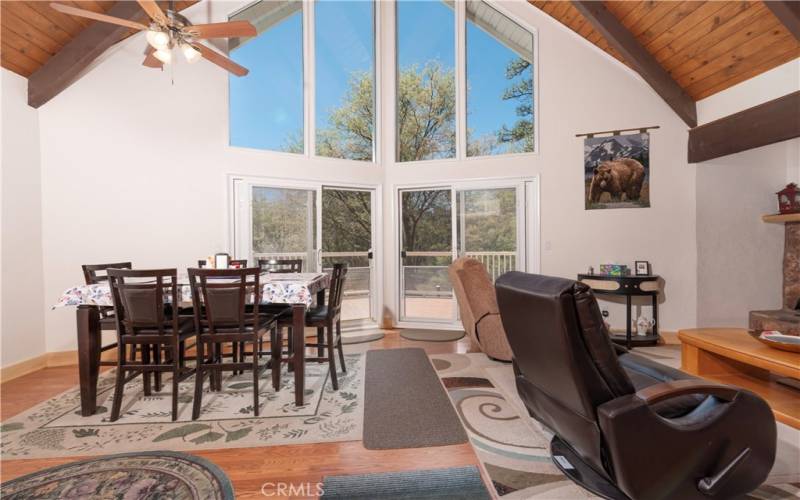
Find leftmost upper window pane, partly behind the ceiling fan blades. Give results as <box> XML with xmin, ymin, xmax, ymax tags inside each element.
<box><xmin>229</xmin><ymin>0</ymin><xmax>304</xmax><ymax>153</ymax></box>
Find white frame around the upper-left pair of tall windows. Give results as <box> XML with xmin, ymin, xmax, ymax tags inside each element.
<box><xmin>227</xmin><ymin>0</ymin><xmax>383</xmax><ymax>166</ymax></box>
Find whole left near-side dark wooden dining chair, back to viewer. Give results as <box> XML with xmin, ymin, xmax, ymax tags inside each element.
<box><xmin>108</xmin><ymin>269</ymin><xmax>195</xmax><ymax>422</ymax></box>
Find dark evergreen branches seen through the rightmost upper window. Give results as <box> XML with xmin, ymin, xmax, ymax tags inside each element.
<box><xmin>497</xmin><ymin>57</ymin><xmax>533</xmax><ymax>152</ymax></box>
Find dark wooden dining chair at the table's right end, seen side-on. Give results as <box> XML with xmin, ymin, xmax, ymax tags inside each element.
<box><xmin>277</xmin><ymin>264</ymin><xmax>347</xmax><ymax>391</ymax></box>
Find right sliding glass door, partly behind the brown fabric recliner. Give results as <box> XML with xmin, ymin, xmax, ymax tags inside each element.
<box><xmin>398</xmin><ymin>180</ymin><xmax>526</xmax><ymax>325</ymax></box>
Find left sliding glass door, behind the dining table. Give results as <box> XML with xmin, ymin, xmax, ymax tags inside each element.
<box><xmin>233</xmin><ymin>178</ymin><xmax>378</xmax><ymax>327</ymax></box>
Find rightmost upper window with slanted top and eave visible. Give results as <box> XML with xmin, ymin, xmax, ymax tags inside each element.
<box><xmin>466</xmin><ymin>0</ymin><xmax>534</xmax><ymax>156</ymax></box>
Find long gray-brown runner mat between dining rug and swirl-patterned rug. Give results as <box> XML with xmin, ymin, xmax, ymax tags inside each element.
<box><xmin>364</xmin><ymin>348</ymin><xmax>467</xmax><ymax>450</ymax></box>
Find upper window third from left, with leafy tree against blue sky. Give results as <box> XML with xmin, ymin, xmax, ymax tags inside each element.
<box><xmin>396</xmin><ymin>0</ymin><xmax>456</xmax><ymax>161</ymax></box>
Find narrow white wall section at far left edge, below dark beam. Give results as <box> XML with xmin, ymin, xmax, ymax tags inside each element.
<box><xmin>0</xmin><ymin>69</ymin><xmax>45</xmax><ymax>367</ymax></box>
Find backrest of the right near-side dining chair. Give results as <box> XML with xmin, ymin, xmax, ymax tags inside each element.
<box><xmin>189</xmin><ymin>267</ymin><xmax>261</xmax><ymax>333</ymax></box>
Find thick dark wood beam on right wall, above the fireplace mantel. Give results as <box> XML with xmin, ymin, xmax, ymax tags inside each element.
<box><xmin>689</xmin><ymin>91</ymin><xmax>800</xmax><ymax>163</ymax></box>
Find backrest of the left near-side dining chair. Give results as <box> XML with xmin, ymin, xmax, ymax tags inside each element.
<box><xmin>108</xmin><ymin>268</ymin><xmax>179</xmax><ymax>335</ymax></box>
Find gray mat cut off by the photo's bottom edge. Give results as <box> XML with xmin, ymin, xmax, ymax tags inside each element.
<box><xmin>321</xmin><ymin>466</ymin><xmax>491</xmax><ymax>500</ymax></box>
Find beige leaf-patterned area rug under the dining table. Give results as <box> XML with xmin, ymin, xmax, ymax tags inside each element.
<box><xmin>0</xmin><ymin>354</ymin><xmax>365</xmax><ymax>459</ymax></box>
